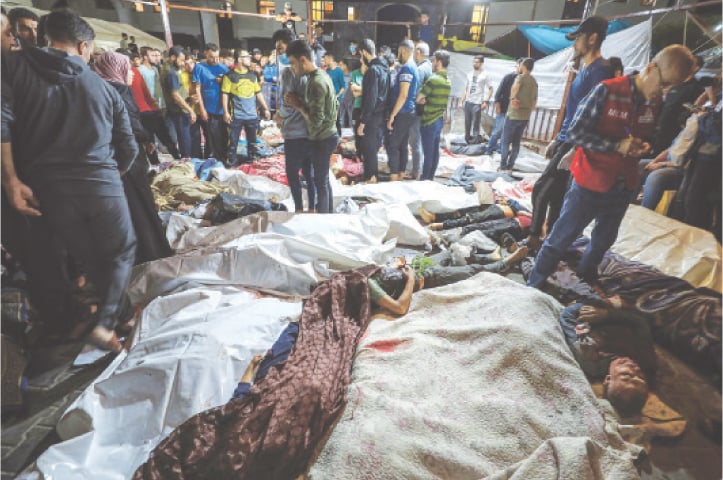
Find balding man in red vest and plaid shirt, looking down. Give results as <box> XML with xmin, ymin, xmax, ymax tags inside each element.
<box><xmin>527</xmin><ymin>45</ymin><xmax>694</xmax><ymax>288</ymax></box>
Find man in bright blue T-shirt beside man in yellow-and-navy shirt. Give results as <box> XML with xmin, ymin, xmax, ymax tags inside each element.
<box><xmin>191</xmin><ymin>43</ymin><xmax>228</xmax><ymax>162</ymax></box>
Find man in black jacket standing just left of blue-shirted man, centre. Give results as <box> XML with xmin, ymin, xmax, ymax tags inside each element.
<box><xmin>357</xmin><ymin>38</ymin><xmax>390</xmax><ymax>183</ymax></box>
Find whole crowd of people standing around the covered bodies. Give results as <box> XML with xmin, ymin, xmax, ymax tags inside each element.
<box><xmin>0</xmin><ymin>1</ymin><xmax>721</xmax><ymax>428</ymax></box>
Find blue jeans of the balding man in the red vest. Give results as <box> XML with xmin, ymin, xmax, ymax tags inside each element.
<box><xmin>527</xmin><ymin>180</ymin><xmax>632</xmax><ymax>288</ymax></box>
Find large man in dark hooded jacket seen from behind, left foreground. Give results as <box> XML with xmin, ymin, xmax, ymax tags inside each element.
<box><xmin>2</xmin><ymin>9</ymin><xmax>138</xmax><ymax>351</ymax></box>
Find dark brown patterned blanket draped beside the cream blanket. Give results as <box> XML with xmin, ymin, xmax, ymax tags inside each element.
<box><xmin>133</xmin><ymin>266</ymin><xmax>377</xmax><ymax>480</ymax></box>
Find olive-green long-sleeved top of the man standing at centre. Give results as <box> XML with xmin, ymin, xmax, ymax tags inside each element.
<box><xmin>304</xmin><ymin>68</ymin><xmax>339</xmax><ymax>140</ymax></box>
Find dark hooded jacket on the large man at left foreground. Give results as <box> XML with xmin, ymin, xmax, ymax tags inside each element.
<box><xmin>2</xmin><ymin>48</ymin><xmax>138</xmax><ymax>196</ymax></box>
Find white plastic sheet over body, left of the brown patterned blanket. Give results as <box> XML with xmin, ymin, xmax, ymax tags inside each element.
<box><xmin>37</xmin><ymin>287</ymin><xmax>301</xmax><ymax>480</ymax></box>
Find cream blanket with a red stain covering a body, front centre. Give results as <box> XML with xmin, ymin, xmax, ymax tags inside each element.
<box><xmin>309</xmin><ymin>273</ymin><xmax>639</xmax><ymax>480</ymax></box>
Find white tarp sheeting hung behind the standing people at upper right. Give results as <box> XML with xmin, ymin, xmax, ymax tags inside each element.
<box><xmin>447</xmin><ymin>20</ymin><xmax>652</xmax><ymax>109</ymax></box>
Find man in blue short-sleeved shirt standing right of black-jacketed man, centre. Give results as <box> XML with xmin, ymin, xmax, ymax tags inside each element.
<box><xmin>387</xmin><ymin>40</ymin><xmax>419</xmax><ymax>181</ymax></box>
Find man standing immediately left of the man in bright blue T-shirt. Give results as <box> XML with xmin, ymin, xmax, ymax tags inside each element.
<box><xmin>162</xmin><ymin>47</ymin><xmax>197</xmax><ymax>158</ymax></box>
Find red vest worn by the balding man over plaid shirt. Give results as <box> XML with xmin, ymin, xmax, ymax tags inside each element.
<box><xmin>570</xmin><ymin>76</ymin><xmax>657</xmax><ymax>192</ymax></box>
